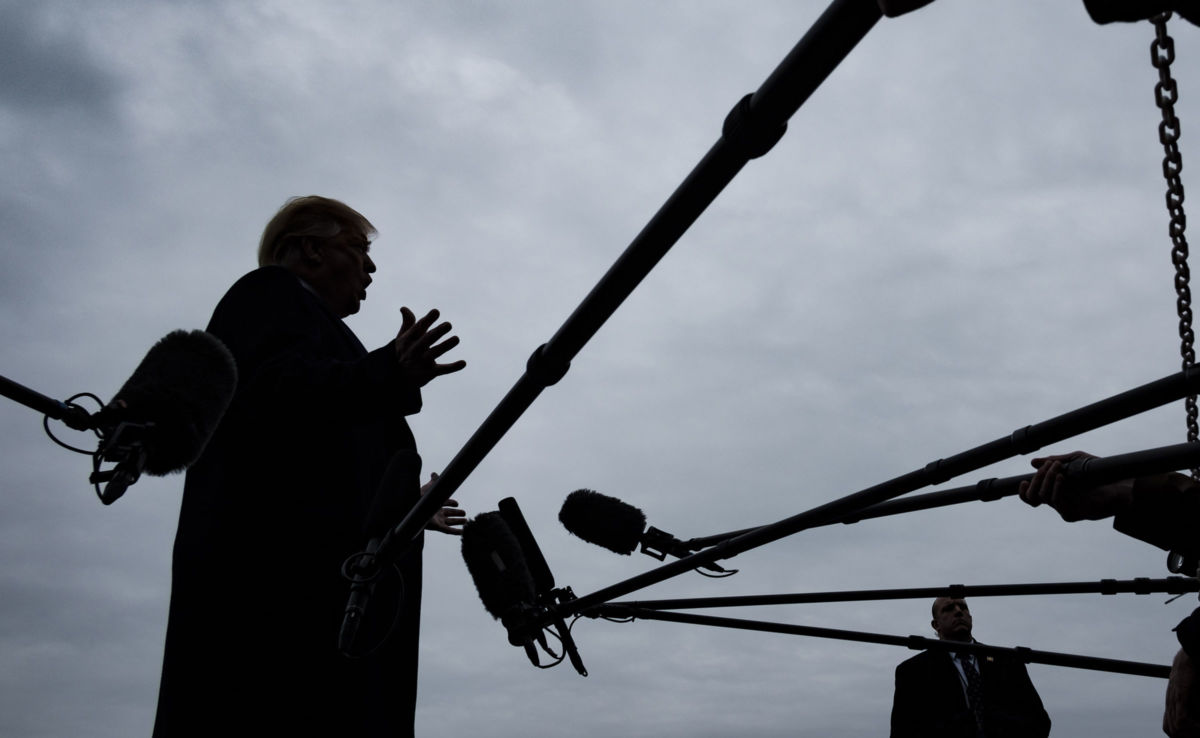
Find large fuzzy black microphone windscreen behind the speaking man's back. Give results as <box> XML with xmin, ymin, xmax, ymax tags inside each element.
<box><xmin>107</xmin><ymin>330</ymin><xmax>238</xmax><ymax>476</ymax></box>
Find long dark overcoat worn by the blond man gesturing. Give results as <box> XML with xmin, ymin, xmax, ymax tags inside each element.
<box><xmin>154</xmin><ymin>266</ymin><xmax>421</xmax><ymax>738</ymax></box>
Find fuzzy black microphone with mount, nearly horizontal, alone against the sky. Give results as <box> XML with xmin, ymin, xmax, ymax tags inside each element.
<box><xmin>558</xmin><ymin>490</ymin><xmax>731</xmax><ymax>574</ymax></box>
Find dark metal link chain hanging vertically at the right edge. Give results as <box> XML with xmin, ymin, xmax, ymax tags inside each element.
<box><xmin>1150</xmin><ymin>12</ymin><xmax>1200</xmax><ymax>479</ymax></box>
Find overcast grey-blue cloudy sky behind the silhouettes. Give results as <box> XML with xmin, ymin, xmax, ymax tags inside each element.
<box><xmin>0</xmin><ymin>0</ymin><xmax>1200</xmax><ymax>737</ymax></box>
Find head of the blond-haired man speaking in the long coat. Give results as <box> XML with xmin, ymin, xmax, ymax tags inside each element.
<box><xmin>258</xmin><ymin>196</ymin><xmax>376</xmax><ymax>318</ymax></box>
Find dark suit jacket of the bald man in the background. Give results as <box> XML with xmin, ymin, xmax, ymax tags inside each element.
<box><xmin>892</xmin><ymin>650</ymin><xmax>1050</xmax><ymax>738</ymax></box>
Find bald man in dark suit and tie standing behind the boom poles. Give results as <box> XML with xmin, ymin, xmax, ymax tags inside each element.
<box><xmin>892</xmin><ymin>598</ymin><xmax>1050</xmax><ymax>738</ymax></box>
